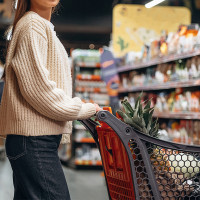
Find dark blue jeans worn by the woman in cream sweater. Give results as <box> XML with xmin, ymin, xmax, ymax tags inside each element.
<box><xmin>6</xmin><ymin>135</ymin><xmax>70</xmax><ymax>200</ymax></box>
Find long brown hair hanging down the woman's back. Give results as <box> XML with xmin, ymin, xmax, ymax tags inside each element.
<box><xmin>3</xmin><ymin>0</ymin><xmax>59</xmax><ymax>78</ymax></box>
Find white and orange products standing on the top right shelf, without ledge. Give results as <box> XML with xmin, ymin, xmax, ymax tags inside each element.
<box><xmin>123</xmin><ymin>24</ymin><xmax>200</xmax><ymax>65</ymax></box>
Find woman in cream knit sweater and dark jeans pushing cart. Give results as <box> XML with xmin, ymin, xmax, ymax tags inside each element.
<box><xmin>0</xmin><ymin>0</ymin><xmax>101</xmax><ymax>200</ymax></box>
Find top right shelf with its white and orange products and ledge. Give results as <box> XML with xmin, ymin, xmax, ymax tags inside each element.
<box><xmin>118</xmin><ymin>24</ymin><xmax>200</xmax><ymax>73</ymax></box>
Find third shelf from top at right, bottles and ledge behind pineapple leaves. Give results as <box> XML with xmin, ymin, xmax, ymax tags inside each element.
<box><xmin>121</xmin><ymin>88</ymin><xmax>200</xmax><ymax>120</ymax></box>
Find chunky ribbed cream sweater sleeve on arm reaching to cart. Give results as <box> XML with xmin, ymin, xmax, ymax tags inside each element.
<box><xmin>11</xmin><ymin>26</ymin><xmax>96</xmax><ymax>121</ymax></box>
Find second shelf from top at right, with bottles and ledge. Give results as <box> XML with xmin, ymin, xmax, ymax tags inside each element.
<box><xmin>119</xmin><ymin>56</ymin><xmax>200</xmax><ymax>93</ymax></box>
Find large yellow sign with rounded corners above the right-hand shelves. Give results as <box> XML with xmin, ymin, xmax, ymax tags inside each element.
<box><xmin>113</xmin><ymin>4</ymin><xmax>191</xmax><ymax>56</ymax></box>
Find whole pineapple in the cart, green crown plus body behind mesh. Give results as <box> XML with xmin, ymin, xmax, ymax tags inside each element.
<box><xmin>117</xmin><ymin>93</ymin><xmax>174</xmax><ymax>196</ymax></box>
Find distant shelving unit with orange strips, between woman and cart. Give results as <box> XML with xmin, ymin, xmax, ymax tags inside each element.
<box><xmin>70</xmin><ymin>50</ymin><xmax>109</xmax><ymax>168</ymax></box>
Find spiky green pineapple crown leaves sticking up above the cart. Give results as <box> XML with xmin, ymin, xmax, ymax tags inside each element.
<box><xmin>117</xmin><ymin>93</ymin><xmax>159</xmax><ymax>138</ymax></box>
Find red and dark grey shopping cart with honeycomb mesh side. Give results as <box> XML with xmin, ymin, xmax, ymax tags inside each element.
<box><xmin>81</xmin><ymin>110</ymin><xmax>200</xmax><ymax>200</ymax></box>
